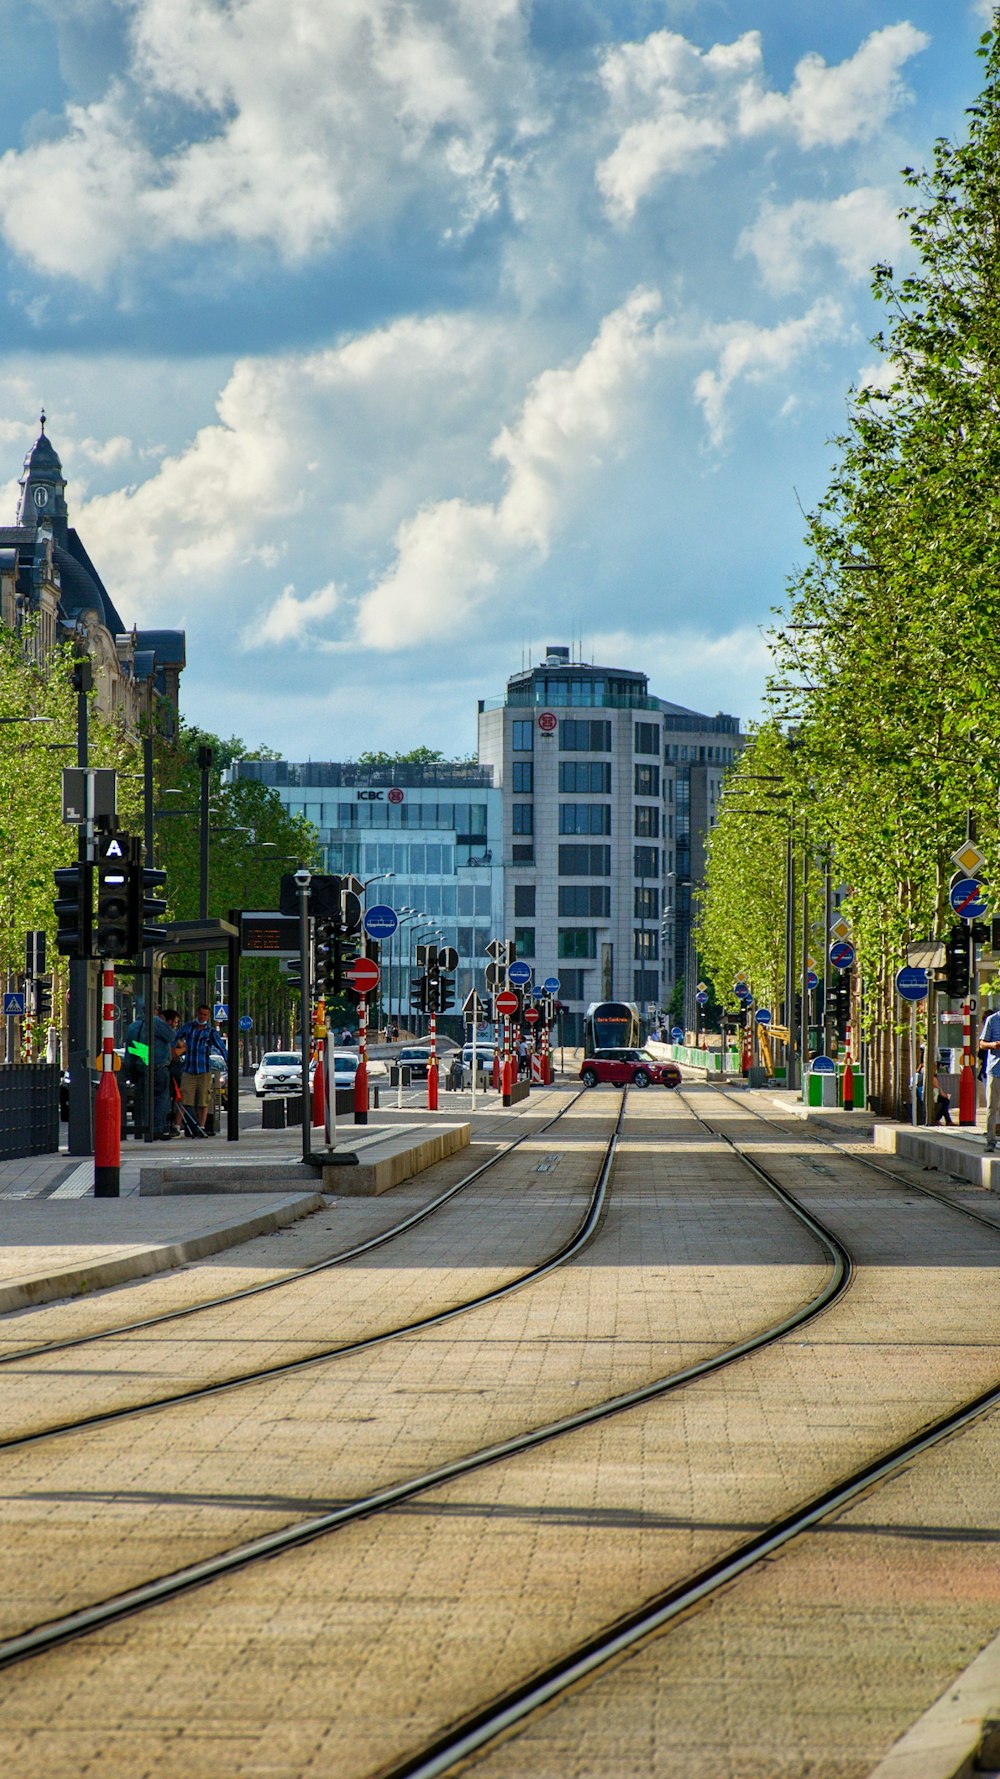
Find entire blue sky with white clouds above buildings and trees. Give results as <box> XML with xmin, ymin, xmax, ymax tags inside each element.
<box><xmin>0</xmin><ymin>0</ymin><xmax>988</xmax><ymax>758</ymax></box>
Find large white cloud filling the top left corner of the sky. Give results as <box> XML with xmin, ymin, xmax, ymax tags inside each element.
<box><xmin>0</xmin><ymin>0</ymin><xmax>536</xmax><ymax>285</ymax></box>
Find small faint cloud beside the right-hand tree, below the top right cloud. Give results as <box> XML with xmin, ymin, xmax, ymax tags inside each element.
<box><xmin>740</xmin><ymin>185</ymin><xmax>909</xmax><ymax>292</ymax></box>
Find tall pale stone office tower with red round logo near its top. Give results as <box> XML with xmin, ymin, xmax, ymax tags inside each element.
<box><xmin>479</xmin><ymin>648</ymin><xmax>744</xmax><ymax>1042</ymax></box>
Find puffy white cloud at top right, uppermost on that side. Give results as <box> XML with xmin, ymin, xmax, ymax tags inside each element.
<box><xmin>596</xmin><ymin>23</ymin><xmax>931</xmax><ymax>222</ymax></box>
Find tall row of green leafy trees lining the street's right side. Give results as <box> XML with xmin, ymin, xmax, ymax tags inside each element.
<box><xmin>699</xmin><ymin>20</ymin><xmax>1000</xmax><ymax>1108</ymax></box>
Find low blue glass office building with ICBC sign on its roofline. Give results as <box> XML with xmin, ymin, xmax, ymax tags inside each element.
<box><xmin>224</xmin><ymin>760</ymin><xmax>504</xmax><ymax>1023</ymax></box>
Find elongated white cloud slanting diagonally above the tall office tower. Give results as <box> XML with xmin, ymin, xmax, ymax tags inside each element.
<box><xmin>350</xmin><ymin>290</ymin><xmax>660</xmax><ymax>649</ymax></box>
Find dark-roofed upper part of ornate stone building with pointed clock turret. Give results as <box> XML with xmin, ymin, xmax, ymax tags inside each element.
<box><xmin>0</xmin><ymin>415</ymin><xmax>185</xmax><ymax>737</ymax></box>
